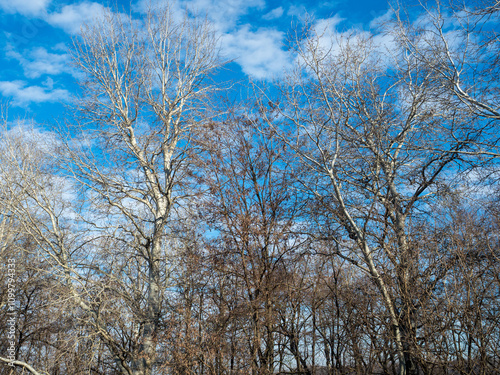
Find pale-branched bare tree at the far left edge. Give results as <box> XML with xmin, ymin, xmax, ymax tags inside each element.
<box><xmin>0</xmin><ymin>122</ymin><xmax>88</xmax><ymax>374</ymax></box>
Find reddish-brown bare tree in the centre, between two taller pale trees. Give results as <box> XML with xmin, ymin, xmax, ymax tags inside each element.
<box><xmin>200</xmin><ymin>109</ymin><xmax>301</xmax><ymax>374</ymax></box>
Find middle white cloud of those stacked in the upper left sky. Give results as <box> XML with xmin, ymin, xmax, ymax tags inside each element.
<box><xmin>6</xmin><ymin>47</ymin><xmax>73</xmax><ymax>78</ymax></box>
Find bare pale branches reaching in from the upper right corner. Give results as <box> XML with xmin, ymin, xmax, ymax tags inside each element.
<box><xmin>387</xmin><ymin>1</ymin><xmax>500</xmax><ymax>147</ymax></box>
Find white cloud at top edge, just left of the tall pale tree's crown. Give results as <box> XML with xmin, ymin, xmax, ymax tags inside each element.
<box><xmin>46</xmin><ymin>2</ymin><xmax>106</xmax><ymax>34</ymax></box>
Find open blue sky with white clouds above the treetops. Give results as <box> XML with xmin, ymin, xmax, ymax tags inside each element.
<box><xmin>0</xmin><ymin>0</ymin><xmax>389</xmax><ymax>122</ymax></box>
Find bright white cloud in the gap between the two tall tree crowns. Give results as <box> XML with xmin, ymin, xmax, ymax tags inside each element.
<box><xmin>222</xmin><ymin>25</ymin><xmax>290</xmax><ymax>79</ymax></box>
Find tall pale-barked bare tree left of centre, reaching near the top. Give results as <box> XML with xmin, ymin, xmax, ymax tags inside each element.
<box><xmin>64</xmin><ymin>7</ymin><xmax>220</xmax><ymax>375</ymax></box>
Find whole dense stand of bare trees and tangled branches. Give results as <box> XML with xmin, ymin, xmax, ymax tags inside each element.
<box><xmin>0</xmin><ymin>2</ymin><xmax>500</xmax><ymax>375</ymax></box>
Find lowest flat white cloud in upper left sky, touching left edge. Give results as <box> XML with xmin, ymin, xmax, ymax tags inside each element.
<box><xmin>0</xmin><ymin>81</ymin><xmax>71</xmax><ymax>106</ymax></box>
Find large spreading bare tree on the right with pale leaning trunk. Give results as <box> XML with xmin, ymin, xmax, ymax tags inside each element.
<box><xmin>263</xmin><ymin>11</ymin><xmax>492</xmax><ymax>374</ymax></box>
